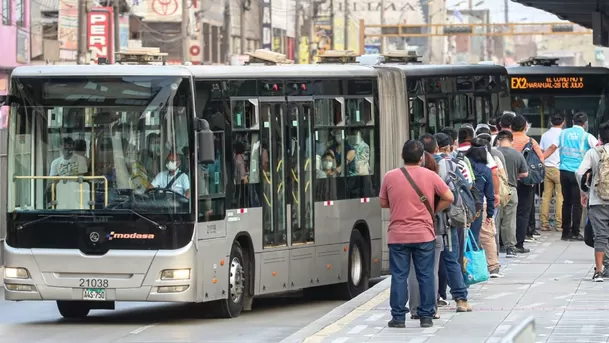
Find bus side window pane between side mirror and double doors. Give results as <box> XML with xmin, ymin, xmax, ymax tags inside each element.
<box><xmin>197</xmin><ymin>131</ymin><xmax>226</xmax><ymax>222</ymax></box>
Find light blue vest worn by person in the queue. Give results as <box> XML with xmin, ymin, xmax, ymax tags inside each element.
<box><xmin>558</xmin><ymin>127</ymin><xmax>591</xmax><ymax>172</ymax></box>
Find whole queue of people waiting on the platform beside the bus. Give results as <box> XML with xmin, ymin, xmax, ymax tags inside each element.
<box><xmin>379</xmin><ymin>112</ymin><xmax>609</xmax><ymax>327</ymax></box>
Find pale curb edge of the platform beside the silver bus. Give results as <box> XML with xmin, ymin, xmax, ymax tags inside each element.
<box><xmin>281</xmin><ymin>277</ymin><xmax>391</xmax><ymax>343</ymax></box>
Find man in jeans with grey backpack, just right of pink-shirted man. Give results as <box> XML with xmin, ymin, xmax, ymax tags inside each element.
<box><xmin>434</xmin><ymin>133</ymin><xmax>475</xmax><ymax>312</ymax></box>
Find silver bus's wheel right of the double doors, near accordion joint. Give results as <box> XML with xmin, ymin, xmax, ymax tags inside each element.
<box><xmin>338</xmin><ymin>230</ymin><xmax>370</xmax><ymax>300</ymax></box>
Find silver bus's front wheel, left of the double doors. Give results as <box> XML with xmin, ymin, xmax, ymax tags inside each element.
<box><xmin>216</xmin><ymin>242</ymin><xmax>243</xmax><ymax>318</ymax></box>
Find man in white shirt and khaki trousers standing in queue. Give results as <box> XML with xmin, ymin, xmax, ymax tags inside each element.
<box><xmin>539</xmin><ymin>112</ymin><xmax>565</xmax><ymax>231</ymax></box>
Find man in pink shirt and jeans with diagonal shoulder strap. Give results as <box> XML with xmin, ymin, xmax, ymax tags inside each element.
<box><xmin>379</xmin><ymin>140</ymin><xmax>453</xmax><ymax>328</ymax></box>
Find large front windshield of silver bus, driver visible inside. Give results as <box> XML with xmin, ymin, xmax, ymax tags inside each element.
<box><xmin>8</xmin><ymin>76</ymin><xmax>192</xmax><ymax>213</ymax></box>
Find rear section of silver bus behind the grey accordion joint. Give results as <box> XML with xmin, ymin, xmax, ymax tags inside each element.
<box><xmin>360</xmin><ymin>51</ymin><xmax>510</xmax><ymax>273</ymax></box>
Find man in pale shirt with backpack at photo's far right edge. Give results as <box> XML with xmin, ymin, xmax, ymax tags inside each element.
<box><xmin>576</xmin><ymin>122</ymin><xmax>609</xmax><ymax>282</ymax></box>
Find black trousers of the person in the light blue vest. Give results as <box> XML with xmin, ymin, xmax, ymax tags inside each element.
<box><xmin>560</xmin><ymin>170</ymin><xmax>583</xmax><ymax>238</ymax></box>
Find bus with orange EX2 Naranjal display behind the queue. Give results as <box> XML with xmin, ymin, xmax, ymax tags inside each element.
<box><xmin>507</xmin><ymin>57</ymin><xmax>609</xmax><ymax>140</ymax></box>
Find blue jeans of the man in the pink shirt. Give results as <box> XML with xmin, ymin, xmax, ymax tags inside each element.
<box><xmin>388</xmin><ymin>239</ymin><xmax>436</xmax><ymax>322</ymax></box>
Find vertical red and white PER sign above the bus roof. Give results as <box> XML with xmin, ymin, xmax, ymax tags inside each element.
<box><xmin>87</xmin><ymin>7</ymin><xmax>114</xmax><ymax>63</ymax></box>
